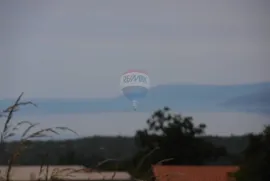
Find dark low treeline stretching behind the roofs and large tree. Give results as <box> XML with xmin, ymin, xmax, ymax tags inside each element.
<box><xmin>0</xmin><ymin>136</ymin><xmax>248</xmax><ymax>167</ymax></box>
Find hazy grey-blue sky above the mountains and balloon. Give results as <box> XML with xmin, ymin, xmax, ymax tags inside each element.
<box><xmin>0</xmin><ymin>0</ymin><xmax>270</xmax><ymax>99</ymax></box>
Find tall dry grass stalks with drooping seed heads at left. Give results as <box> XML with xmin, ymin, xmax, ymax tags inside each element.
<box><xmin>0</xmin><ymin>93</ymin><xmax>77</xmax><ymax>181</ymax></box>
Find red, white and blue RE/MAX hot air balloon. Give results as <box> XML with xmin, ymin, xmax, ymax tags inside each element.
<box><xmin>120</xmin><ymin>70</ymin><xmax>150</xmax><ymax>111</ymax></box>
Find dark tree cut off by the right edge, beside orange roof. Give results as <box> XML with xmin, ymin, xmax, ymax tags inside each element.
<box><xmin>235</xmin><ymin>125</ymin><xmax>270</xmax><ymax>181</ymax></box>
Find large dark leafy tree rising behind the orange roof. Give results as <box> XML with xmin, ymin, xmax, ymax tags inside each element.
<box><xmin>134</xmin><ymin>107</ymin><xmax>226</xmax><ymax>175</ymax></box>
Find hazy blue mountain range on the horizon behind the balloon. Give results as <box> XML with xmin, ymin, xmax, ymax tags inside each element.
<box><xmin>0</xmin><ymin>82</ymin><xmax>270</xmax><ymax>114</ymax></box>
